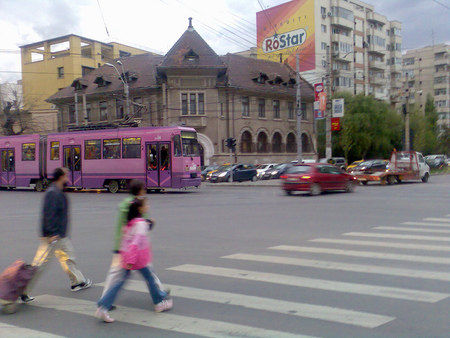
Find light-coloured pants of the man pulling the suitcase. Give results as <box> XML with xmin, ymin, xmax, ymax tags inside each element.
<box><xmin>24</xmin><ymin>237</ymin><xmax>85</xmax><ymax>294</ymax></box>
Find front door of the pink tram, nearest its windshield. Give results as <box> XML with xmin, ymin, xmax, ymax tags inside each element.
<box><xmin>145</xmin><ymin>142</ymin><xmax>172</xmax><ymax>188</ymax></box>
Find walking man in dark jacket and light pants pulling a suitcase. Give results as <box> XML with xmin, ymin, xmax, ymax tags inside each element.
<box><xmin>21</xmin><ymin>168</ymin><xmax>92</xmax><ymax>303</ymax></box>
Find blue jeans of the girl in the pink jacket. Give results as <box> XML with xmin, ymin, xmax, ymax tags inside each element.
<box><xmin>97</xmin><ymin>266</ymin><xmax>167</xmax><ymax>309</ymax></box>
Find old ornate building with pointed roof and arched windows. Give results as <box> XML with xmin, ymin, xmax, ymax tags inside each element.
<box><xmin>47</xmin><ymin>22</ymin><xmax>316</xmax><ymax>164</ymax></box>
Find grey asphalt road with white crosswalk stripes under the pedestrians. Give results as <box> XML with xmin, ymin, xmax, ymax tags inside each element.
<box><xmin>0</xmin><ymin>176</ymin><xmax>450</xmax><ymax>337</ymax></box>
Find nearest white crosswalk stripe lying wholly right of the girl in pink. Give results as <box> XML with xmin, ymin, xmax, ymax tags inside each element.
<box><xmin>167</xmin><ymin>264</ymin><xmax>450</xmax><ymax>303</ymax></box>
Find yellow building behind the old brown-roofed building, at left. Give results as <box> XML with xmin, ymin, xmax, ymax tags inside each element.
<box><xmin>20</xmin><ymin>34</ymin><xmax>153</xmax><ymax>133</ymax></box>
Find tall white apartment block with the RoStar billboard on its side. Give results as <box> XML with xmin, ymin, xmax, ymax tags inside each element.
<box><xmin>257</xmin><ymin>0</ymin><xmax>402</xmax><ymax>104</ymax></box>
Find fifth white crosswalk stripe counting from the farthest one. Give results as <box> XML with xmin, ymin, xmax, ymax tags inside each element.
<box><xmin>309</xmin><ymin>238</ymin><xmax>450</xmax><ymax>252</ymax></box>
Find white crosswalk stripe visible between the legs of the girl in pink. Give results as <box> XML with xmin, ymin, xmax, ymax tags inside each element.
<box><xmin>99</xmin><ymin>280</ymin><xmax>395</xmax><ymax>328</ymax></box>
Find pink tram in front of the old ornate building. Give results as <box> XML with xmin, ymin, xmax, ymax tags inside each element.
<box><xmin>0</xmin><ymin>127</ymin><xmax>201</xmax><ymax>193</ymax></box>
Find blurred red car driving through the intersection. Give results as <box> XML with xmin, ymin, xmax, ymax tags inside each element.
<box><xmin>280</xmin><ymin>163</ymin><xmax>358</xmax><ymax>196</ymax></box>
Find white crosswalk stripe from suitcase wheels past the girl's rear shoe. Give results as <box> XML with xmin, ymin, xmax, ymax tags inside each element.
<box><xmin>32</xmin><ymin>295</ymin><xmax>310</xmax><ymax>338</ymax></box>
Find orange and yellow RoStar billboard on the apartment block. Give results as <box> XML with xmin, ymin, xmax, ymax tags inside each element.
<box><xmin>256</xmin><ymin>0</ymin><xmax>316</xmax><ymax>72</ymax></box>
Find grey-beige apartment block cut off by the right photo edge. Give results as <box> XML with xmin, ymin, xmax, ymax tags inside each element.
<box><xmin>403</xmin><ymin>44</ymin><xmax>450</xmax><ymax>127</ymax></box>
